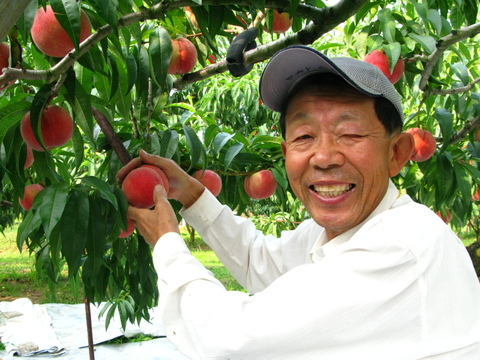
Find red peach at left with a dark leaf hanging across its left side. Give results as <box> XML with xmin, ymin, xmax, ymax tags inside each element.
<box><xmin>20</xmin><ymin>105</ymin><xmax>73</xmax><ymax>151</ymax></box>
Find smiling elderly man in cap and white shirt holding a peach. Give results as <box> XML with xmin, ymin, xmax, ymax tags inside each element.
<box><xmin>118</xmin><ymin>46</ymin><xmax>480</xmax><ymax>360</ymax></box>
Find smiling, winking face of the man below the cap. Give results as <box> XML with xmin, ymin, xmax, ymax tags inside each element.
<box><xmin>282</xmin><ymin>89</ymin><xmax>402</xmax><ymax>239</ymax></box>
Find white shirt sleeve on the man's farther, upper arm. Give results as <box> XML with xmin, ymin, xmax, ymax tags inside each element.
<box><xmin>181</xmin><ymin>191</ymin><xmax>321</xmax><ymax>293</ymax></box>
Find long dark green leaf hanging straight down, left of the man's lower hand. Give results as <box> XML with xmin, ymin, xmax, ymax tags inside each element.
<box><xmin>61</xmin><ymin>191</ymin><xmax>89</xmax><ymax>278</ymax></box>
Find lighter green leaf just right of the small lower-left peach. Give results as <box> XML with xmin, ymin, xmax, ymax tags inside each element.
<box><xmin>39</xmin><ymin>182</ymin><xmax>68</xmax><ymax>238</ymax></box>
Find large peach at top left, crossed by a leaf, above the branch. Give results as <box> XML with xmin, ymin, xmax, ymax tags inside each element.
<box><xmin>30</xmin><ymin>5</ymin><xmax>92</xmax><ymax>57</ymax></box>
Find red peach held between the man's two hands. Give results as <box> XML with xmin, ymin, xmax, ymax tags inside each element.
<box><xmin>122</xmin><ymin>166</ymin><xmax>166</xmax><ymax>209</ymax></box>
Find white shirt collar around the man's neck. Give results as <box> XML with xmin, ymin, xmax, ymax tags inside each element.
<box><xmin>310</xmin><ymin>180</ymin><xmax>400</xmax><ymax>262</ymax></box>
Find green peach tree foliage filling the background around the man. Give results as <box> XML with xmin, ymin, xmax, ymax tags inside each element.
<box><xmin>0</xmin><ymin>0</ymin><xmax>480</xmax><ymax>321</ymax></box>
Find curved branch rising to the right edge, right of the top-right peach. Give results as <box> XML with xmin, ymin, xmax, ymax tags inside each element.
<box><xmin>418</xmin><ymin>23</ymin><xmax>480</xmax><ymax>91</ymax></box>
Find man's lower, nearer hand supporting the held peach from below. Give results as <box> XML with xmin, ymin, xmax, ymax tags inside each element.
<box><xmin>127</xmin><ymin>185</ymin><xmax>180</xmax><ymax>247</ymax></box>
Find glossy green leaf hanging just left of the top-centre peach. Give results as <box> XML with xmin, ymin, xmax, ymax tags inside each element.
<box><xmin>148</xmin><ymin>26</ymin><xmax>172</xmax><ymax>89</ymax></box>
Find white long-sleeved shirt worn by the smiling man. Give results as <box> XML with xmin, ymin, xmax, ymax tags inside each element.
<box><xmin>154</xmin><ymin>183</ymin><xmax>480</xmax><ymax>360</ymax></box>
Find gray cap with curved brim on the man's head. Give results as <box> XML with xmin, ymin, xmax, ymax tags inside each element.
<box><xmin>260</xmin><ymin>46</ymin><xmax>404</xmax><ymax>121</ymax></box>
